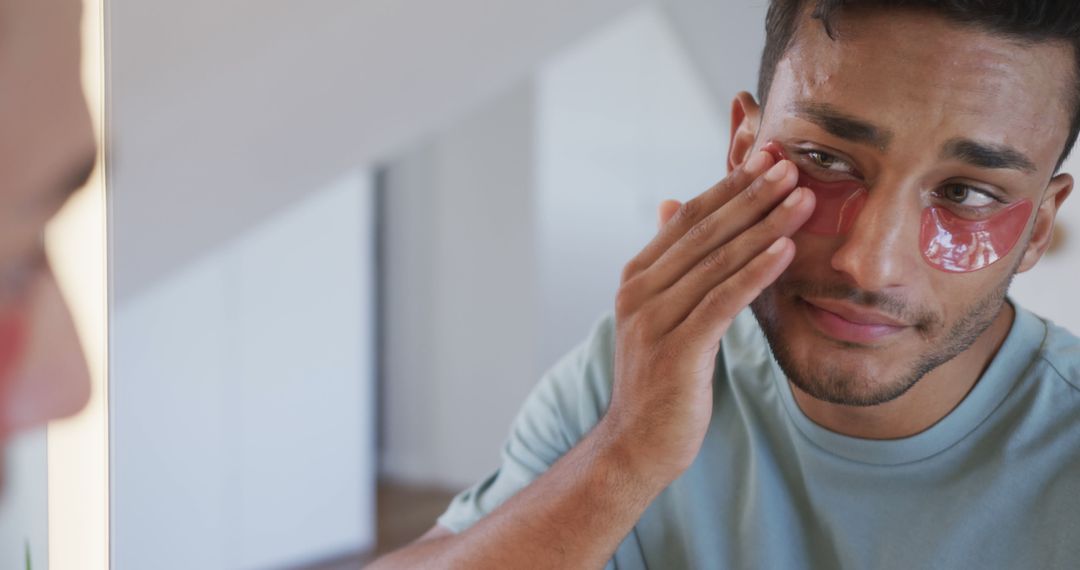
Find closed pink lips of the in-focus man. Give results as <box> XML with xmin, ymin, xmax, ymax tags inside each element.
<box><xmin>798</xmin><ymin>297</ymin><xmax>910</xmax><ymax>344</ymax></box>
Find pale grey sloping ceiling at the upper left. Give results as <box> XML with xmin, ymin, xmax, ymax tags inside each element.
<box><xmin>106</xmin><ymin>0</ymin><xmax>643</xmax><ymax>302</ymax></box>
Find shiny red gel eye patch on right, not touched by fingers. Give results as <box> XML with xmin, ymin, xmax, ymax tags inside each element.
<box><xmin>919</xmin><ymin>200</ymin><xmax>1035</xmax><ymax>273</ymax></box>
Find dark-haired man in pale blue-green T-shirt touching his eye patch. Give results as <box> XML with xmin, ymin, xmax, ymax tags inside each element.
<box><xmin>376</xmin><ymin>0</ymin><xmax>1080</xmax><ymax>569</ymax></box>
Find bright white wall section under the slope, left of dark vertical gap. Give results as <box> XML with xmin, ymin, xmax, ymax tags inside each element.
<box><xmin>110</xmin><ymin>172</ymin><xmax>374</xmax><ymax>570</ymax></box>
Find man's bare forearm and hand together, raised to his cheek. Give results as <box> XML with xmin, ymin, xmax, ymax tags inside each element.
<box><xmin>373</xmin><ymin>141</ymin><xmax>813</xmax><ymax>569</ymax></box>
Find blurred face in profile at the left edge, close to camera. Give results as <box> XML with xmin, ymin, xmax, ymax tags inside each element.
<box><xmin>0</xmin><ymin>0</ymin><xmax>96</xmax><ymax>481</ymax></box>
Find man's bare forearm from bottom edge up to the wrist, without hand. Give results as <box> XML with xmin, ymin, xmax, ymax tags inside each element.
<box><xmin>372</xmin><ymin>423</ymin><xmax>666</xmax><ymax>570</ymax></box>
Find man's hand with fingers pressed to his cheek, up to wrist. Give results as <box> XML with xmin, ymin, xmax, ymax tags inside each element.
<box><xmin>602</xmin><ymin>151</ymin><xmax>814</xmax><ymax>485</ymax></box>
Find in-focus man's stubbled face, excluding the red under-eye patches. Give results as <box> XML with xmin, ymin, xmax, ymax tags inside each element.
<box><xmin>737</xmin><ymin>11</ymin><xmax>1075</xmax><ymax>405</ymax></box>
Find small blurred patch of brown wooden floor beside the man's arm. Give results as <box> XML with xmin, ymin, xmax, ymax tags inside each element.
<box><xmin>295</xmin><ymin>481</ymin><xmax>455</xmax><ymax>570</ymax></box>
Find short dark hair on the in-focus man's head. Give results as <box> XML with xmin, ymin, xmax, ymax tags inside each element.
<box><xmin>757</xmin><ymin>0</ymin><xmax>1080</xmax><ymax>168</ymax></box>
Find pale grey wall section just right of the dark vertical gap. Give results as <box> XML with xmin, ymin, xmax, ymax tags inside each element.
<box><xmin>382</xmin><ymin>84</ymin><xmax>538</xmax><ymax>487</ymax></box>
